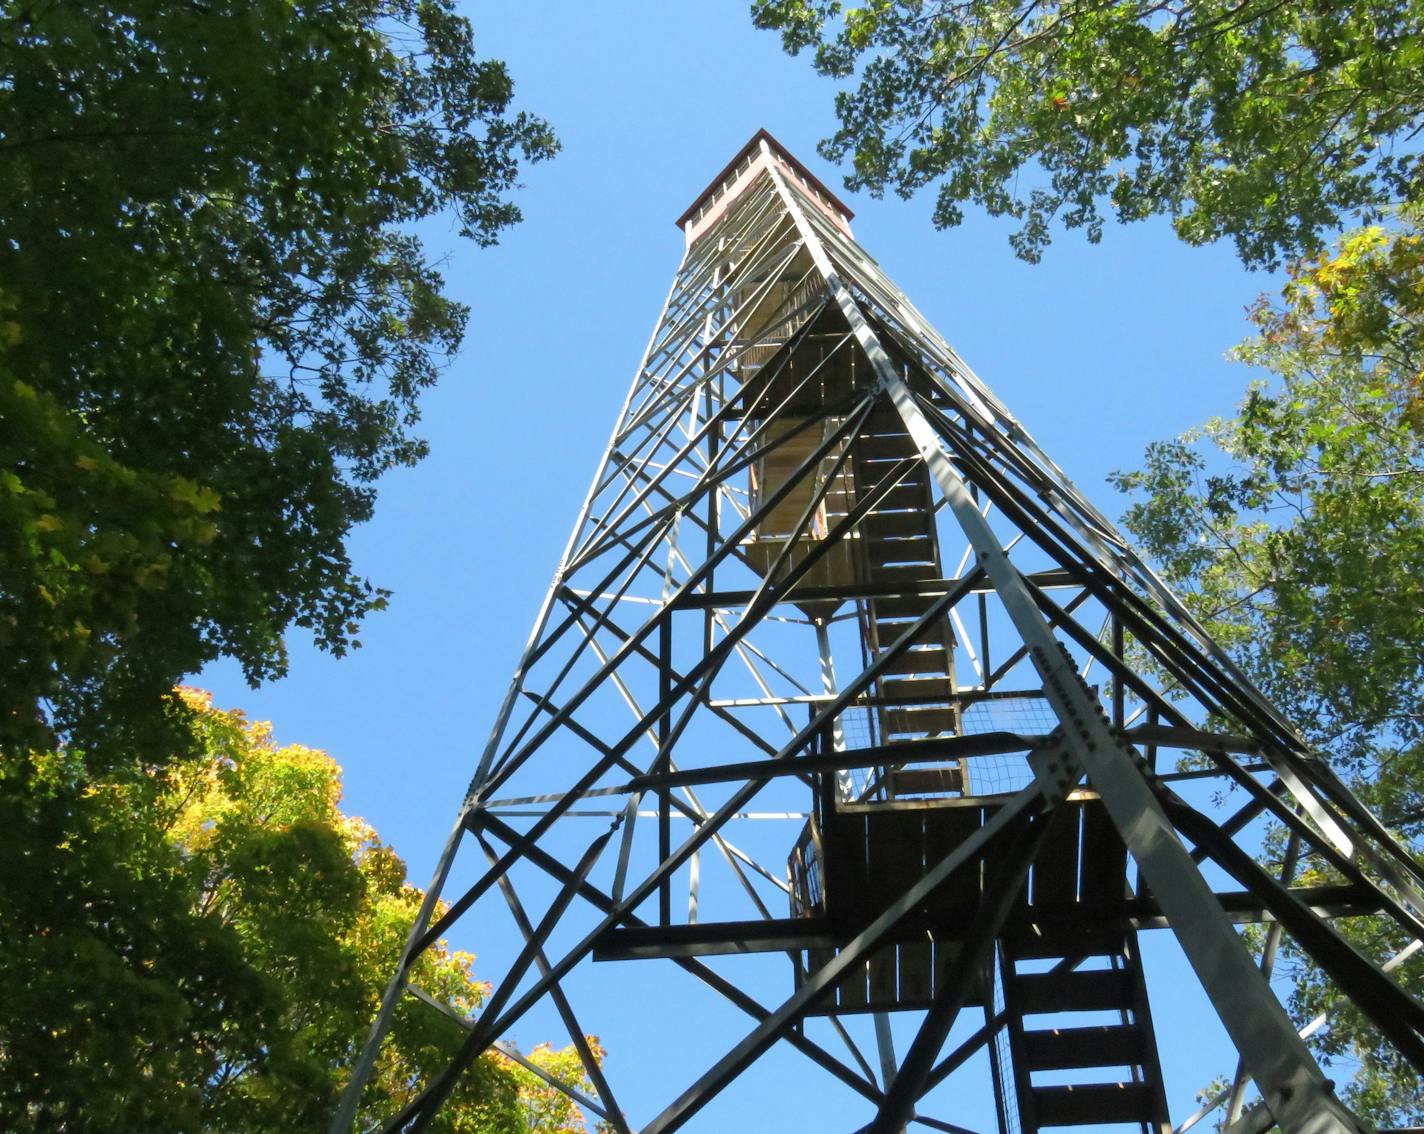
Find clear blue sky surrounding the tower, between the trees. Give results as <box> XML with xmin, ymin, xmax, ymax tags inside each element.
<box><xmin>202</xmin><ymin>0</ymin><xmax>1292</xmax><ymax>1130</ymax></box>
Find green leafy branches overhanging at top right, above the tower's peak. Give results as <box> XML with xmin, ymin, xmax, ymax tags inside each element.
<box><xmin>752</xmin><ymin>0</ymin><xmax>1424</xmax><ymax>266</ymax></box>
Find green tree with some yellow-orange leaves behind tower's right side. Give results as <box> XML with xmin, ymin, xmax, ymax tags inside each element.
<box><xmin>1115</xmin><ymin>211</ymin><xmax>1424</xmax><ymax>1124</ymax></box>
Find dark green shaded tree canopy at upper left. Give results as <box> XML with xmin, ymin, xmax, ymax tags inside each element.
<box><xmin>0</xmin><ymin>0</ymin><xmax>557</xmax><ymax>775</ymax></box>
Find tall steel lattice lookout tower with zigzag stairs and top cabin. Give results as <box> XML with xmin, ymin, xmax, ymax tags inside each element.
<box><xmin>332</xmin><ymin>131</ymin><xmax>1424</xmax><ymax>1134</ymax></box>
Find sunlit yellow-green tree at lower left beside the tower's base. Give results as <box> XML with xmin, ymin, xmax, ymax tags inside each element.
<box><xmin>0</xmin><ymin>691</ymin><xmax>597</xmax><ymax>1134</ymax></box>
